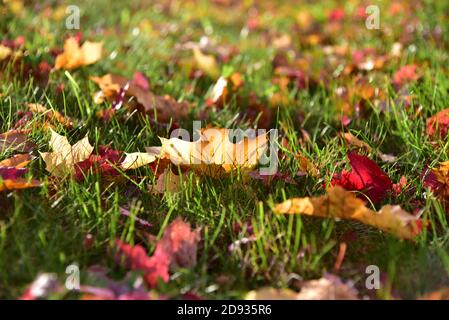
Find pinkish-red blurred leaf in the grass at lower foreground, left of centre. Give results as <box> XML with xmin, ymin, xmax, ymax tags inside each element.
<box><xmin>116</xmin><ymin>218</ymin><xmax>200</xmax><ymax>287</ymax></box>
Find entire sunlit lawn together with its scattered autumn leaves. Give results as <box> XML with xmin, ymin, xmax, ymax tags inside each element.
<box><xmin>0</xmin><ymin>0</ymin><xmax>449</xmax><ymax>299</ymax></box>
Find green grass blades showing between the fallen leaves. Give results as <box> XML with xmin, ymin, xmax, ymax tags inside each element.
<box><xmin>0</xmin><ymin>1</ymin><xmax>449</xmax><ymax>298</ymax></box>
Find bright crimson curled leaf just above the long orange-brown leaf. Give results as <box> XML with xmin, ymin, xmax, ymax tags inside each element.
<box><xmin>331</xmin><ymin>152</ymin><xmax>393</xmax><ymax>203</ymax></box>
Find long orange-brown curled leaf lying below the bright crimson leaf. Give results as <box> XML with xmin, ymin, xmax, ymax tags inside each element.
<box><xmin>274</xmin><ymin>186</ymin><xmax>422</xmax><ymax>239</ymax></box>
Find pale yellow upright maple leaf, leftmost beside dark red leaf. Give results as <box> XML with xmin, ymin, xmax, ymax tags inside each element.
<box><xmin>39</xmin><ymin>129</ymin><xmax>94</xmax><ymax>177</ymax></box>
